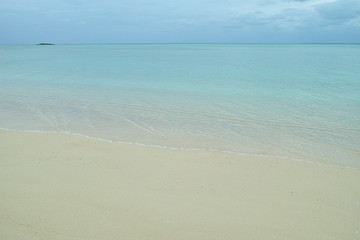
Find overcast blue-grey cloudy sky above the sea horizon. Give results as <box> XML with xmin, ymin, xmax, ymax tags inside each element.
<box><xmin>0</xmin><ymin>0</ymin><xmax>360</xmax><ymax>44</ymax></box>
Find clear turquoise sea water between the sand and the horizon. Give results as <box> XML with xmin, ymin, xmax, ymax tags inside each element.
<box><xmin>0</xmin><ymin>44</ymin><xmax>360</xmax><ymax>167</ymax></box>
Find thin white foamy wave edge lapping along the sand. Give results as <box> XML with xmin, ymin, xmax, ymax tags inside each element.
<box><xmin>0</xmin><ymin>127</ymin><xmax>360</xmax><ymax>170</ymax></box>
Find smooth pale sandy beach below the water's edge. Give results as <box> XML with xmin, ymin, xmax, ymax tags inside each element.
<box><xmin>0</xmin><ymin>130</ymin><xmax>360</xmax><ymax>240</ymax></box>
